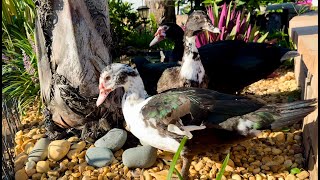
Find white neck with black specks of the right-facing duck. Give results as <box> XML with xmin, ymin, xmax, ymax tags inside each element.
<box><xmin>180</xmin><ymin>35</ymin><xmax>205</xmax><ymax>83</ymax></box>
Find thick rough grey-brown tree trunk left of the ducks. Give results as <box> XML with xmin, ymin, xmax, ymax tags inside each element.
<box><xmin>36</xmin><ymin>0</ymin><xmax>123</xmax><ymax>139</ymax></box>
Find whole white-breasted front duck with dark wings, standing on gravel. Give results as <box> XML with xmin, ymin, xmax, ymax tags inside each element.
<box><xmin>96</xmin><ymin>63</ymin><xmax>317</xmax><ymax>179</ymax></box>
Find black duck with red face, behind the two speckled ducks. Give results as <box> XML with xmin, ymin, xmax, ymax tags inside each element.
<box><xmin>133</xmin><ymin>12</ymin><xmax>300</xmax><ymax>95</ymax></box>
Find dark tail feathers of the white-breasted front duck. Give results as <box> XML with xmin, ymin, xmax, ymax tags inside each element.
<box><xmin>255</xmin><ymin>99</ymin><xmax>317</xmax><ymax>130</ymax></box>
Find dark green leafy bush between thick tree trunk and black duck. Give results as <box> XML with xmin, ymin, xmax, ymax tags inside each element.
<box><xmin>109</xmin><ymin>0</ymin><xmax>173</xmax><ymax>58</ymax></box>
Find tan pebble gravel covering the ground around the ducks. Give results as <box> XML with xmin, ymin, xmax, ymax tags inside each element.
<box><xmin>14</xmin><ymin>65</ymin><xmax>309</xmax><ymax>180</ymax></box>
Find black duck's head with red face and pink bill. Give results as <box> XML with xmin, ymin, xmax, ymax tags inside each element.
<box><xmin>149</xmin><ymin>23</ymin><xmax>184</xmax><ymax>47</ymax></box>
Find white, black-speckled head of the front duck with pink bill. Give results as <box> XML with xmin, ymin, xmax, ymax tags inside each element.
<box><xmin>96</xmin><ymin>63</ymin><xmax>139</xmax><ymax>106</ymax></box>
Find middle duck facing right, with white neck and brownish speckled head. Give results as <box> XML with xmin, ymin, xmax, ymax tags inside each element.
<box><xmin>157</xmin><ymin>10</ymin><xmax>220</xmax><ymax>93</ymax></box>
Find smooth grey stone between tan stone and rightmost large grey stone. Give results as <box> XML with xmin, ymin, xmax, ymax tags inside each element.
<box><xmin>85</xmin><ymin>147</ymin><xmax>114</xmax><ymax>167</ymax></box>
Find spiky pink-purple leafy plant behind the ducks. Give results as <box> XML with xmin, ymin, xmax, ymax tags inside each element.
<box><xmin>196</xmin><ymin>2</ymin><xmax>268</xmax><ymax>48</ymax></box>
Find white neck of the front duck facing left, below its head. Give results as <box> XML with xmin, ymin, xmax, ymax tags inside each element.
<box><xmin>122</xmin><ymin>76</ymin><xmax>148</xmax><ymax>108</ymax></box>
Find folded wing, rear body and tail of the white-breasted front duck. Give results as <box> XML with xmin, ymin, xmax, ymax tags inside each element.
<box><xmin>141</xmin><ymin>88</ymin><xmax>317</xmax><ymax>140</ymax></box>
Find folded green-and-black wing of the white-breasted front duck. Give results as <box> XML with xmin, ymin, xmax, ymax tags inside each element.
<box><xmin>141</xmin><ymin>88</ymin><xmax>262</xmax><ymax>138</ymax></box>
